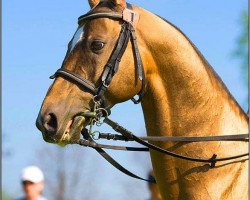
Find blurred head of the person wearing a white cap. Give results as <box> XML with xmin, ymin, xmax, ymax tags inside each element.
<box><xmin>21</xmin><ymin>166</ymin><xmax>44</xmax><ymax>199</ymax></box>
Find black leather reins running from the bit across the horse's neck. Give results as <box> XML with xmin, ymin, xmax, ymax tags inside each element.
<box><xmin>72</xmin><ymin>111</ymin><xmax>249</xmax><ymax>183</ymax></box>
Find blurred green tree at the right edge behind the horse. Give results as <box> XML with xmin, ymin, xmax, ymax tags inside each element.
<box><xmin>233</xmin><ymin>11</ymin><xmax>248</xmax><ymax>85</ymax></box>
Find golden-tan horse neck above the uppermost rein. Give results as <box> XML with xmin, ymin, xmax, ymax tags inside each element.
<box><xmin>138</xmin><ymin>9</ymin><xmax>248</xmax><ymax>138</ymax></box>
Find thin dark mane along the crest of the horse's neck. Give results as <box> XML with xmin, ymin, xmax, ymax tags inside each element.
<box><xmin>155</xmin><ymin>14</ymin><xmax>249</xmax><ymax>120</ymax></box>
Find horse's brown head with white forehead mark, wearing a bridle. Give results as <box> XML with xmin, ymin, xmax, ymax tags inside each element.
<box><xmin>36</xmin><ymin>0</ymin><xmax>145</xmax><ymax>144</ymax></box>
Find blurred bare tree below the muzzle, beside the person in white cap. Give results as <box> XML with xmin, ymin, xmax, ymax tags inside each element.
<box><xmin>37</xmin><ymin>144</ymin><xmax>101</xmax><ymax>200</ymax></box>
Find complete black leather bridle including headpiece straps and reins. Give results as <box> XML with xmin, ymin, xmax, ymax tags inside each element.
<box><xmin>50</xmin><ymin>4</ymin><xmax>249</xmax><ymax>183</ymax></box>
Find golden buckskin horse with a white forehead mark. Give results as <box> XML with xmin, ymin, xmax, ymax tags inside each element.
<box><xmin>36</xmin><ymin>0</ymin><xmax>248</xmax><ymax>200</ymax></box>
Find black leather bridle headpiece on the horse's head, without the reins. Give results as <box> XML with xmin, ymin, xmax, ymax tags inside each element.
<box><xmin>50</xmin><ymin>4</ymin><xmax>145</xmax><ymax>109</ymax></box>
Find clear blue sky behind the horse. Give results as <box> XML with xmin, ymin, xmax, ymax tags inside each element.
<box><xmin>2</xmin><ymin>0</ymin><xmax>247</xmax><ymax>199</ymax></box>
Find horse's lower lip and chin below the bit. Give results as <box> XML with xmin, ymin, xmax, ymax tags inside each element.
<box><xmin>57</xmin><ymin>116</ymin><xmax>87</xmax><ymax>146</ymax></box>
